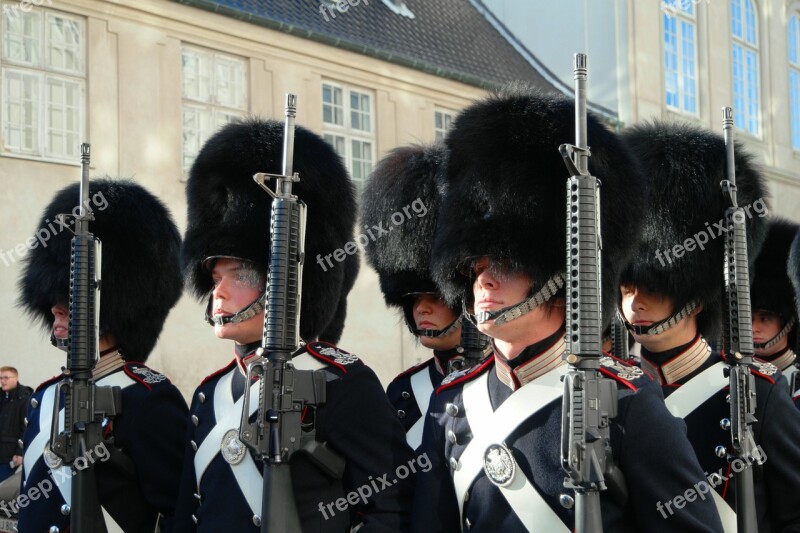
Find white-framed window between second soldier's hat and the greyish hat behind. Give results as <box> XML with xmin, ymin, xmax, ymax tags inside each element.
<box><xmin>322</xmin><ymin>82</ymin><xmax>375</xmax><ymax>189</ymax></box>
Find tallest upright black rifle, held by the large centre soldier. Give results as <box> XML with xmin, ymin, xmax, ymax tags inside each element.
<box><xmin>559</xmin><ymin>54</ymin><xmax>617</xmax><ymax>533</ymax></box>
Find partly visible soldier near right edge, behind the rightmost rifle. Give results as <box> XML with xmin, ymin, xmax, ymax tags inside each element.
<box><xmin>750</xmin><ymin>219</ymin><xmax>800</xmax><ymax>397</ymax></box>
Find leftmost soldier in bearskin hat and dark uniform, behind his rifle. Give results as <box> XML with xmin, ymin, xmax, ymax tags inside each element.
<box><xmin>18</xmin><ymin>179</ymin><xmax>188</xmax><ymax>532</ymax></box>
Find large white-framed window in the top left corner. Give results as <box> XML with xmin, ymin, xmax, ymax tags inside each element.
<box><xmin>0</xmin><ymin>3</ymin><xmax>86</xmax><ymax>164</ymax></box>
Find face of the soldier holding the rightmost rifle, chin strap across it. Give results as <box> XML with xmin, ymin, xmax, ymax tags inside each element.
<box><xmin>620</xmin><ymin>285</ymin><xmax>702</xmax><ymax>352</ymax></box>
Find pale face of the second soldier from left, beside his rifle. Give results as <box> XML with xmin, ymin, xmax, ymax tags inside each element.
<box><xmin>211</xmin><ymin>258</ymin><xmax>264</xmax><ymax>344</ymax></box>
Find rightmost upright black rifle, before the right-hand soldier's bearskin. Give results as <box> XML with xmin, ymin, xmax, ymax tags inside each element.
<box><xmin>718</xmin><ymin>107</ymin><xmax>763</xmax><ymax>533</ymax></box>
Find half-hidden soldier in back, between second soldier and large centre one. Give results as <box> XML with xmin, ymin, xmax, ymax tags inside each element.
<box><xmin>360</xmin><ymin>145</ymin><xmax>485</xmax><ymax>449</ymax></box>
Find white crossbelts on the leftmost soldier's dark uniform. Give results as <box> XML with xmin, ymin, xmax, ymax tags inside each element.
<box><xmin>23</xmin><ymin>371</ymin><xmax>134</xmax><ymax>531</ymax></box>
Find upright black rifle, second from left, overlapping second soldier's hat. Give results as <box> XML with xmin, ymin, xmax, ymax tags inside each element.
<box><xmin>239</xmin><ymin>94</ymin><xmax>344</xmax><ymax>533</ymax></box>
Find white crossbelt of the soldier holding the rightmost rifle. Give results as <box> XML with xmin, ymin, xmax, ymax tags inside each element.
<box><xmin>664</xmin><ymin>361</ymin><xmax>737</xmax><ymax>533</ymax></box>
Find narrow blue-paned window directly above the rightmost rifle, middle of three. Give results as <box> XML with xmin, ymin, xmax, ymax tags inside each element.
<box><xmin>731</xmin><ymin>0</ymin><xmax>760</xmax><ymax>135</ymax></box>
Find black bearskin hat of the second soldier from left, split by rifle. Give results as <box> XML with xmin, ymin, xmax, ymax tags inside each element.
<box><xmin>183</xmin><ymin>119</ymin><xmax>356</xmax><ymax>340</ymax></box>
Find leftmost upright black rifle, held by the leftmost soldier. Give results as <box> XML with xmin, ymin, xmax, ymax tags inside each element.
<box><xmin>50</xmin><ymin>143</ymin><xmax>122</xmax><ymax>532</ymax></box>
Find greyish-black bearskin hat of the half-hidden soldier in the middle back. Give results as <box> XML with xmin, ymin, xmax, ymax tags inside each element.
<box><xmin>360</xmin><ymin>145</ymin><xmax>446</xmax><ymax>307</ymax></box>
